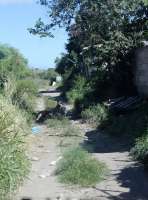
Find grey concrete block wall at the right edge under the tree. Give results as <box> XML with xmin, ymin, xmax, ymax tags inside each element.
<box><xmin>135</xmin><ymin>46</ymin><xmax>148</xmax><ymax>97</ymax></box>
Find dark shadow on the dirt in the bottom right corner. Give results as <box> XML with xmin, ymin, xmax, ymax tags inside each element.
<box><xmin>110</xmin><ymin>164</ymin><xmax>148</xmax><ymax>200</ymax></box>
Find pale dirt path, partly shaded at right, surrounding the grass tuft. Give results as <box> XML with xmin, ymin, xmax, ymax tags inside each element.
<box><xmin>14</xmin><ymin>91</ymin><xmax>148</xmax><ymax>200</ymax></box>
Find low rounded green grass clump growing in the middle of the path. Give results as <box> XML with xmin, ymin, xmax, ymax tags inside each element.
<box><xmin>56</xmin><ymin>148</ymin><xmax>107</xmax><ymax>186</ymax></box>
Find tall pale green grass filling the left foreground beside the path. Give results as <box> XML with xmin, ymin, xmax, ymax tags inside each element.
<box><xmin>0</xmin><ymin>97</ymin><xmax>29</xmax><ymax>199</ymax></box>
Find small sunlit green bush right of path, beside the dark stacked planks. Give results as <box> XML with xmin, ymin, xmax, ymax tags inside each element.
<box><xmin>81</xmin><ymin>104</ymin><xmax>108</xmax><ymax>125</ymax></box>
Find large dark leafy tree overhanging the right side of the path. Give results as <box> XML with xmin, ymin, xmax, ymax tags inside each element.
<box><xmin>30</xmin><ymin>0</ymin><xmax>148</xmax><ymax>99</ymax></box>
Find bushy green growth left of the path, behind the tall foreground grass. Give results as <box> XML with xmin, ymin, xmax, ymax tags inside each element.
<box><xmin>3</xmin><ymin>76</ymin><xmax>37</xmax><ymax>123</ymax></box>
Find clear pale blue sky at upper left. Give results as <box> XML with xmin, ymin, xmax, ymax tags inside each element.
<box><xmin>0</xmin><ymin>0</ymin><xmax>67</xmax><ymax>68</ymax></box>
